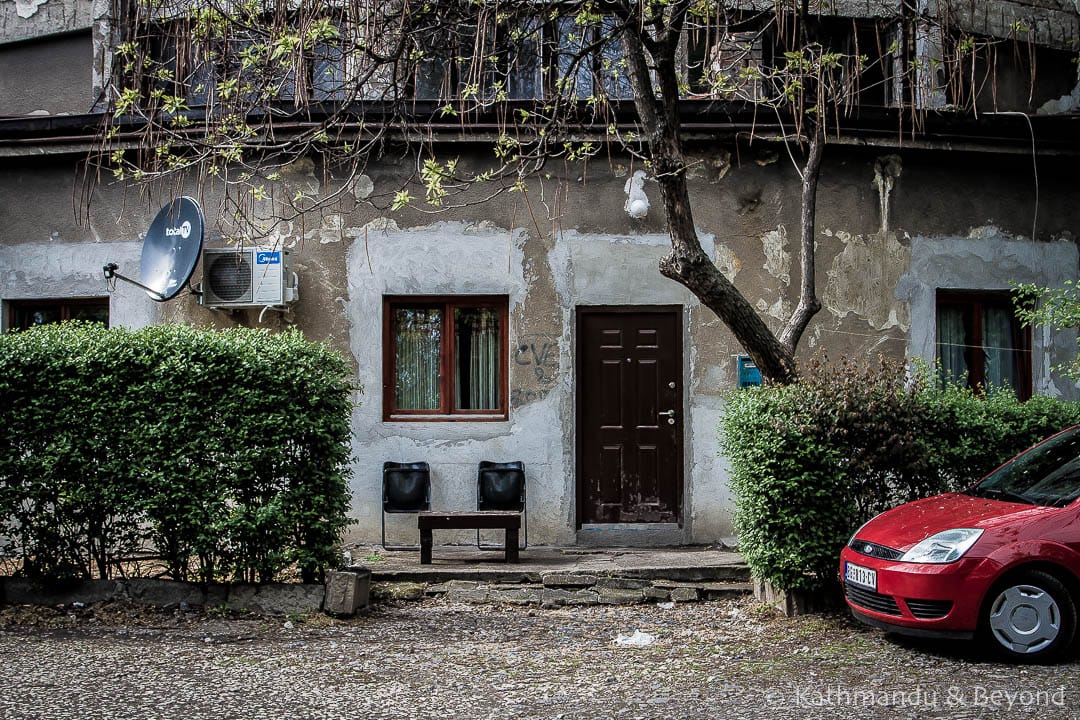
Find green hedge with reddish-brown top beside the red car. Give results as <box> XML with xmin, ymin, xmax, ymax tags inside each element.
<box><xmin>720</xmin><ymin>363</ymin><xmax>1080</xmax><ymax>590</ymax></box>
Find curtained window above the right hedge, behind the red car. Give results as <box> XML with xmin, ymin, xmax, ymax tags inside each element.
<box><xmin>937</xmin><ymin>290</ymin><xmax>1031</xmax><ymax>399</ymax></box>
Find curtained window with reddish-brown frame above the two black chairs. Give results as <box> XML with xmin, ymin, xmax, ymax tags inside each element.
<box><xmin>383</xmin><ymin>296</ymin><xmax>508</xmax><ymax>420</ymax></box>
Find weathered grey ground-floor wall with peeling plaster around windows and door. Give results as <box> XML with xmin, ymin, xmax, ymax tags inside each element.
<box><xmin>0</xmin><ymin>144</ymin><xmax>1080</xmax><ymax>544</ymax></box>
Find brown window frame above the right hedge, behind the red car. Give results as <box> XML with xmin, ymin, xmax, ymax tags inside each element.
<box><xmin>934</xmin><ymin>289</ymin><xmax>1034</xmax><ymax>400</ymax></box>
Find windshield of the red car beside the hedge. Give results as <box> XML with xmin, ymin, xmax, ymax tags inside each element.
<box><xmin>967</xmin><ymin>427</ymin><xmax>1080</xmax><ymax>507</ymax></box>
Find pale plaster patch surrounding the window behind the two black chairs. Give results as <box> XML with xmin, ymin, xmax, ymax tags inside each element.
<box><xmin>348</xmin><ymin>221</ymin><xmax>569</xmax><ymax>543</ymax></box>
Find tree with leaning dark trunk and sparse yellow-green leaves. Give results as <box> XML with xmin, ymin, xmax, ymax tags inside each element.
<box><xmin>92</xmin><ymin>0</ymin><xmax>1045</xmax><ymax>382</ymax></box>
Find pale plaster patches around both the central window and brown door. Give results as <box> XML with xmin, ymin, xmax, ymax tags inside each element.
<box><xmin>348</xmin><ymin>222</ymin><xmax>730</xmax><ymax>544</ymax></box>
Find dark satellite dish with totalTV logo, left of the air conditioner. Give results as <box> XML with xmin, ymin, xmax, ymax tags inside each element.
<box><xmin>138</xmin><ymin>195</ymin><xmax>205</xmax><ymax>302</ymax></box>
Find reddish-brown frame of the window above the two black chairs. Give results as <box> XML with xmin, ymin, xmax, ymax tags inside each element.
<box><xmin>382</xmin><ymin>295</ymin><xmax>510</xmax><ymax>422</ymax></box>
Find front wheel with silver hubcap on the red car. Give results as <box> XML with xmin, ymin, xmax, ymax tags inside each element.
<box><xmin>982</xmin><ymin>570</ymin><xmax>1077</xmax><ymax>663</ymax></box>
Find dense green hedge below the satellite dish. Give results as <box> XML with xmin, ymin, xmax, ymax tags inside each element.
<box><xmin>0</xmin><ymin>323</ymin><xmax>355</xmax><ymax>582</ymax></box>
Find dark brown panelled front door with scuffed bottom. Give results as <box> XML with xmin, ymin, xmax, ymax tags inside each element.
<box><xmin>577</xmin><ymin>308</ymin><xmax>683</xmax><ymax>525</ymax></box>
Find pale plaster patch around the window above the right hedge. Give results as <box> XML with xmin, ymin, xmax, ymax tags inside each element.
<box><xmin>895</xmin><ymin>227</ymin><xmax>1080</xmax><ymax>399</ymax></box>
